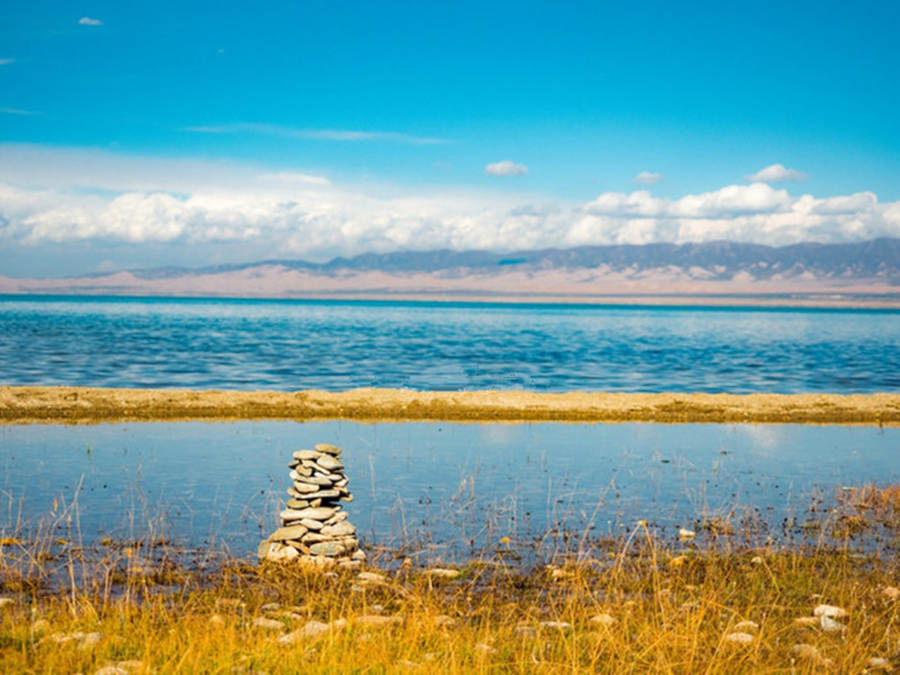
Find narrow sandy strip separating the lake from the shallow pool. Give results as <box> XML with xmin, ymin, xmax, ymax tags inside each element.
<box><xmin>0</xmin><ymin>387</ymin><xmax>900</xmax><ymax>426</ymax></box>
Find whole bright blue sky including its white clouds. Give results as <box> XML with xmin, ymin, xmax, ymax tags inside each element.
<box><xmin>0</xmin><ymin>0</ymin><xmax>900</xmax><ymax>276</ymax></box>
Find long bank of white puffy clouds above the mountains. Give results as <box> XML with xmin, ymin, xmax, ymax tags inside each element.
<box><xmin>0</xmin><ymin>151</ymin><xmax>900</xmax><ymax>273</ymax></box>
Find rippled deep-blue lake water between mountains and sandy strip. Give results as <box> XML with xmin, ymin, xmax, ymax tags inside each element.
<box><xmin>0</xmin><ymin>296</ymin><xmax>900</xmax><ymax>393</ymax></box>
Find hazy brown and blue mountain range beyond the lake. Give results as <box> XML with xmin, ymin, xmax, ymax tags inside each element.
<box><xmin>0</xmin><ymin>238</ymin><xmax>900</xmax><ymax>306</ymax></box>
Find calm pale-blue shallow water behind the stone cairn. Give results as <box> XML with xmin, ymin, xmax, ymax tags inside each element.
<box><xmin>0</xmin><ymin>421</ymin><xmax>900</xmax><ymax>562</ymax></box>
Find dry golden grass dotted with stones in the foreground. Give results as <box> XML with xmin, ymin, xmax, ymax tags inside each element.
<box><xmin>0</xmin><ymin>526</ymin><xmax>900</xmax><ymax>673</ymax></box>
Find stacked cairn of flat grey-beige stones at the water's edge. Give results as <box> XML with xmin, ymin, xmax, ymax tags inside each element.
<box><xmin>259</xmin><ymin>443</ymin><xmax>366</xmax><ymax>566</ymax></box>
